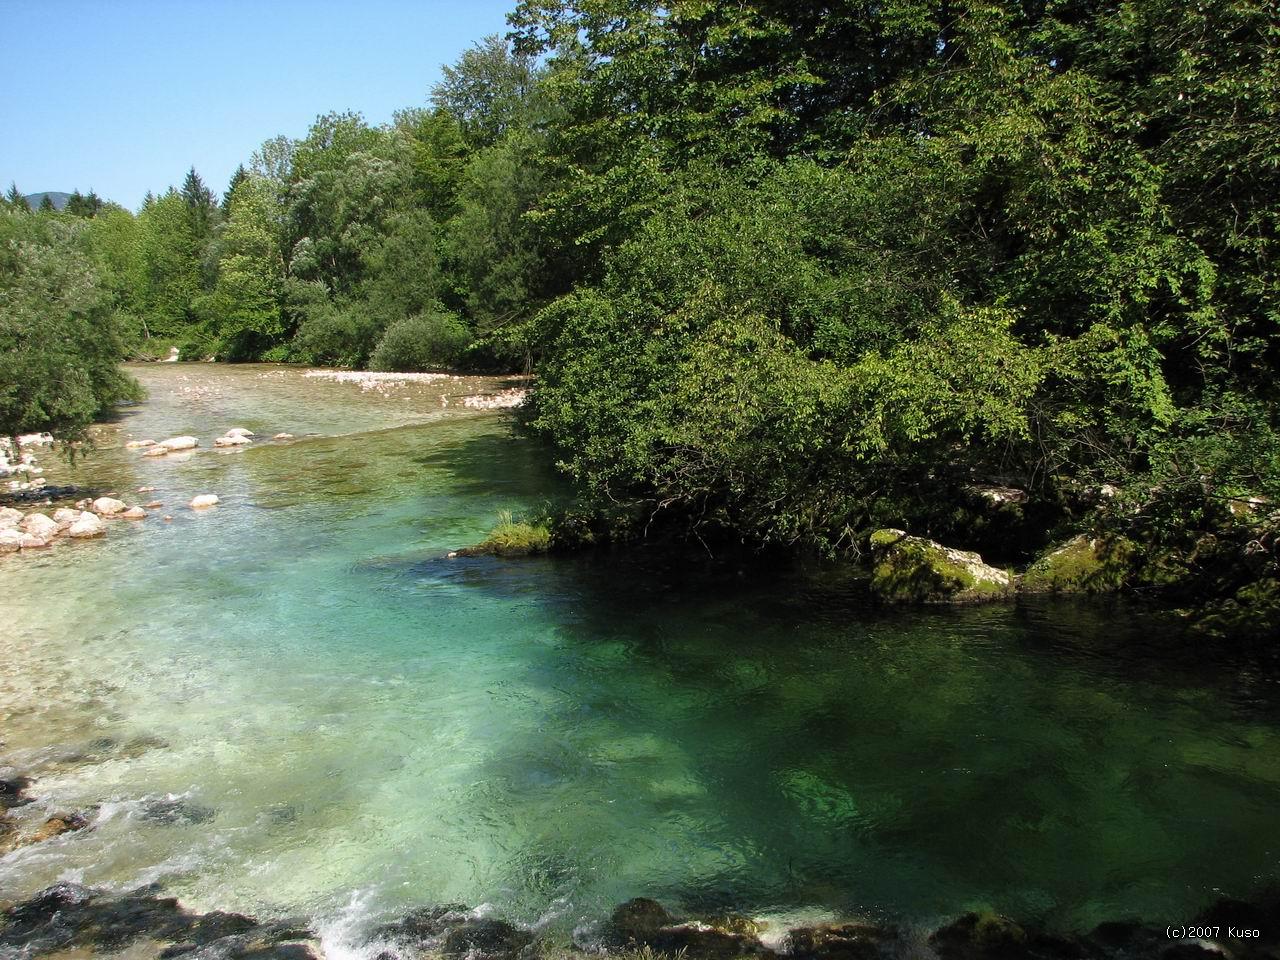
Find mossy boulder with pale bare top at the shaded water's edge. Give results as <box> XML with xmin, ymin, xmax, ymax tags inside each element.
<box><xmin>870</xmin><ymin>530</ymin><xmax>1012</xmax><ymax>603</ymax></box>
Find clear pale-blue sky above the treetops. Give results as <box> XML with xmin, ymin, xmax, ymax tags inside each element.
<box><xmin>0</xmin><ymin>0</ymin><xmax>516</xmax><ymax>209</ymax></box>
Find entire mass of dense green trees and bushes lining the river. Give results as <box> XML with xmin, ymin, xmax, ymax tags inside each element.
<box><xmin>0</xmin><ymin>0</ymin><xmax>1280</xmax><ymax>636</ymax></box>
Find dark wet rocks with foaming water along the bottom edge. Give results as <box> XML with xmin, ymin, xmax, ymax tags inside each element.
<box><xmin>0</xmin><ymin>883</ymin><xmax>1280</xmax><ymax>960</ymax></box>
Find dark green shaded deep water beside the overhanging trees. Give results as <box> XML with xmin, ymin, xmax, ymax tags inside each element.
<box><xmin>404</xmin><ymin>550</ymin><xmax>1280</xmax><ymax>928</ymax></box>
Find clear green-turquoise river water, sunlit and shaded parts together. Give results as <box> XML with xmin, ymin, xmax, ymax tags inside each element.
<box><xmin>0</xmin><ymin>365</ymin><xmax>1280</xmax><ymax>940</ymax></box>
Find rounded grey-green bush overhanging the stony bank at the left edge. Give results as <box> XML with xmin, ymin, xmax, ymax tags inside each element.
<box><xmin>0</xmin><ymin>211</ymin><xmax>140</xmax><ymax>439</ymax></box>
